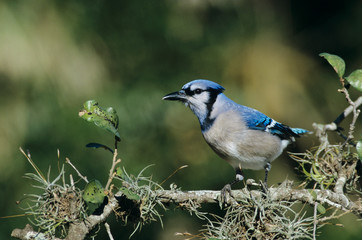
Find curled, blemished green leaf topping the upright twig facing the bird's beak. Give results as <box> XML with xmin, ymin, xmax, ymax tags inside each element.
<box><xmin>79</xmin><ymin>100</ymin><xmax>120</xmax><ymax>138</ymax></box>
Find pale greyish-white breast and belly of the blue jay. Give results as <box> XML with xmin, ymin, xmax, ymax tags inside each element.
<box><xmin>203</xmin><ymin>110</ymin><xmax>289</xmax><ymax>170</ymax></box>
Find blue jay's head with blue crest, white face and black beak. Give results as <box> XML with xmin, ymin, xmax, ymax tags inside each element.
<box><xmin>162</xmin><ymin>79</ymin><xmax>225</xmax><ymax>122</ymax></box>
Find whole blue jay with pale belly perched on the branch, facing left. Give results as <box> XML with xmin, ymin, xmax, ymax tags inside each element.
<box><xmin>162</xmin><ymin>79</ymin><xmax>308</xmax><ymax>192</ymax></box>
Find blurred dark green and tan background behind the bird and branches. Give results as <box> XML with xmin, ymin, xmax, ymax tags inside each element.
<box><xmin>0</xmin><ymin>0</ymin><xmax>362</xmax><ymax>239</ymax></box>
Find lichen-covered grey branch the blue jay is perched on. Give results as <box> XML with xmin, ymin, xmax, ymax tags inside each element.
<box><xmin>11</xmin><ymin>180</ymin><xmax>362</xmax><ymax>240</ymax></box>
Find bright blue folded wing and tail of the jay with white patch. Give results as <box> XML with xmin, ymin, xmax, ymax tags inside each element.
<box><xmin>241</xmin><ymin>106</ymin><xmax>308</xmax><ymax>139</ymax></box>
